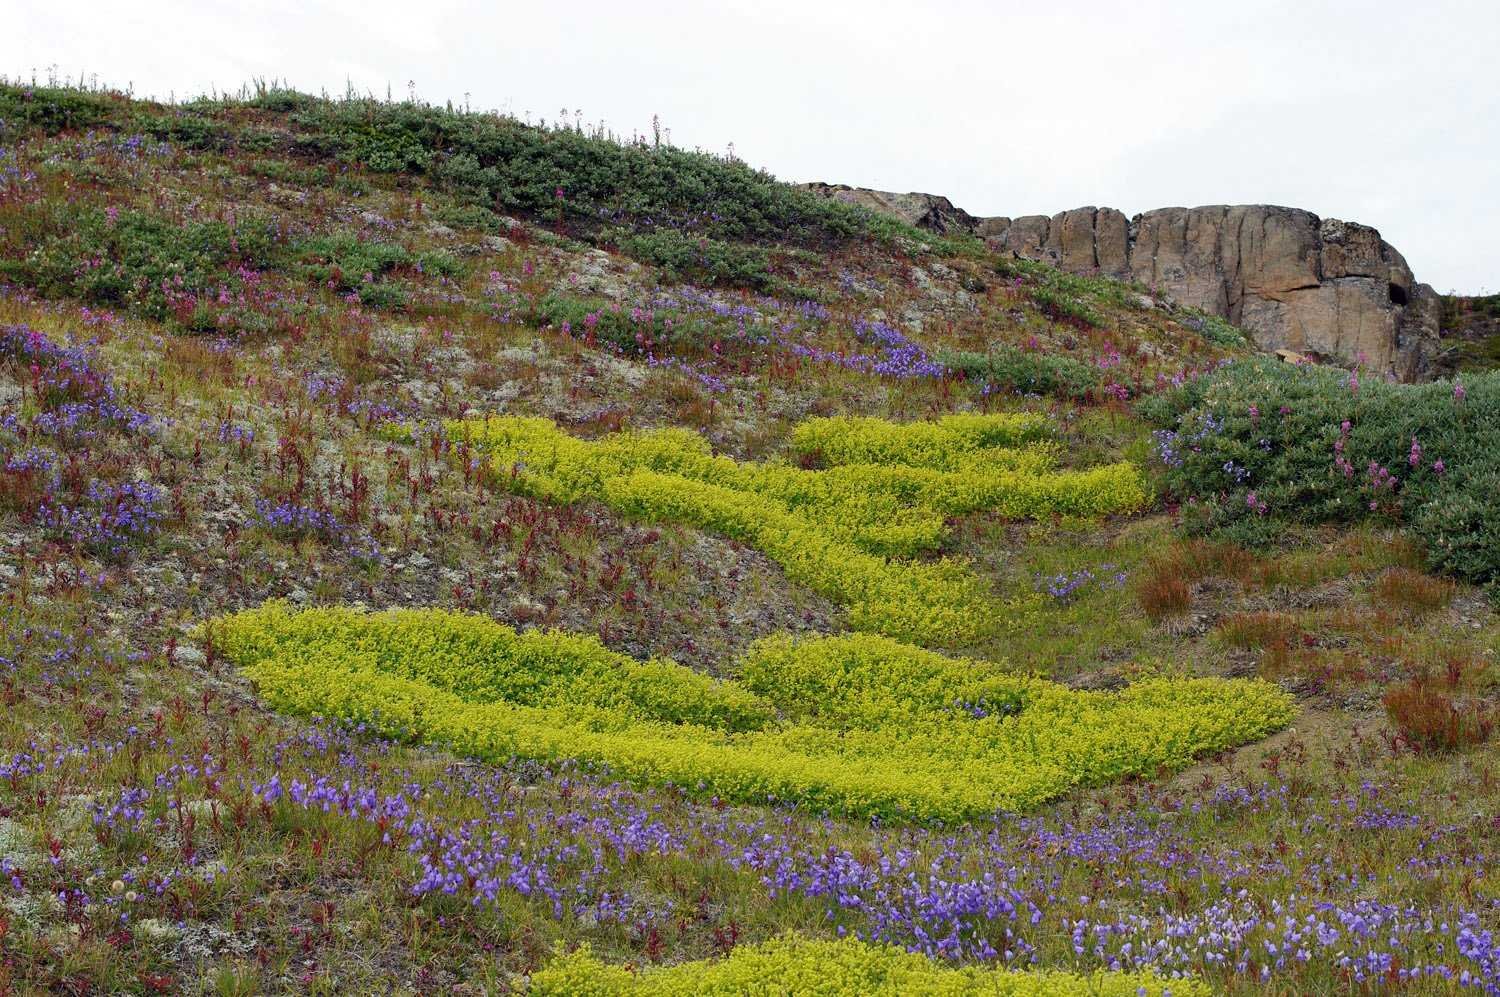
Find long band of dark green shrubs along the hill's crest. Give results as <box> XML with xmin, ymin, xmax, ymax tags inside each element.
<box><xmin>0</xmin><ymin>87</ymin><xmax>954</xmax><ymax>289</ymax></box>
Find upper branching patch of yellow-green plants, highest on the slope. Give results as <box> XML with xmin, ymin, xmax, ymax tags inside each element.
<box><xmin>447</xmin><ymin>415</ymin><xmax>1146</xmax><ymax>645</ymax></box>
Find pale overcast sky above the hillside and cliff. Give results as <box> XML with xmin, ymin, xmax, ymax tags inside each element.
<box><xmin>11</xmin><ymin>0</ymin><xmax>1500</xmax><ymax>294</ymax></box>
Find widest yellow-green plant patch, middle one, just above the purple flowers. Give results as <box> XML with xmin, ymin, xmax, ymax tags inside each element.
<box><xmin>206</xmin><ymin>603</ymin><xmax>1295</xmax><ymax>822</ymax></box>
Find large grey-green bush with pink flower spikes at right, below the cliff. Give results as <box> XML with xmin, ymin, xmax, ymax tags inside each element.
<box><xmin>1140</xmin><ymin>358</ymin><xmax>1500</xmax><ymax>583</ymax></box>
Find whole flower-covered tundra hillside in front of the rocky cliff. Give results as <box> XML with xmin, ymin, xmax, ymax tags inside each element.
<box><xmin>0</xmin><ymin>82</ymin><xmax>1500</xmax><ymax>997</ymax></box>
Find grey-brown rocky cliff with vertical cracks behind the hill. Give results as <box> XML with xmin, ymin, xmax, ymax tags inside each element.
<box><xmin>809</xmin><ymin>184</ymin><xmax>1440</xmax><ymax>381</ymax></box>
